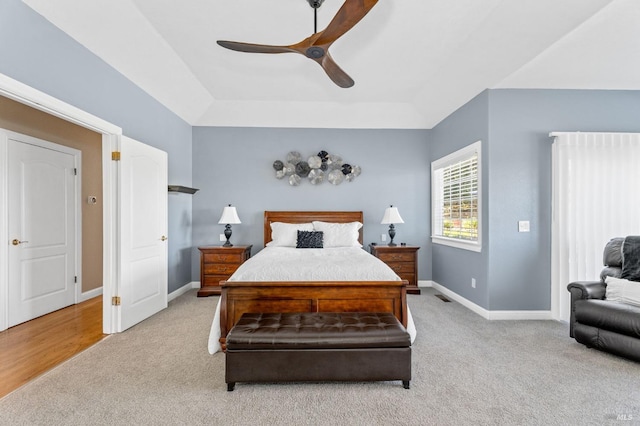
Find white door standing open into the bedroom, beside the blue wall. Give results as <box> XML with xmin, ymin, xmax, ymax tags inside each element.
<box><xmin>118</xmin><ymin>137</ymin><xmax>168</xmax><ymax>331</ymax></box>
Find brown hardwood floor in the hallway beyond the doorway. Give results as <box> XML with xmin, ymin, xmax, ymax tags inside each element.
<box><xmin>0</xmin><ymin>296</ymin><xmax>106</xmax><ymax>398</ymax></box>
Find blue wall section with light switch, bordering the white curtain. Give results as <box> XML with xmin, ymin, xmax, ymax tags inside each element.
<box><xmin>489</xmin><ymin>90</ymin><xmax>640</xmax><ymax>310</ymax></box>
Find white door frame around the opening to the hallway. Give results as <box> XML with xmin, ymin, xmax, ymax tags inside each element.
<box><xmin>0</xmin><ymin>73</ymin><xmax>122</xmax><ymax>334</ymax></box>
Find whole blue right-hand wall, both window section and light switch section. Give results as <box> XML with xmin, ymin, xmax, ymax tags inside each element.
<box><xmin>429</xmin><ymin>90</ymin><xmax>640</xmax><ymax>310</ymax></box>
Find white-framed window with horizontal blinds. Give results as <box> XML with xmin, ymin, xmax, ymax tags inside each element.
<box><xmin>431</xmin><ymin>141</ymin><xmax>482</xmax><ymax>251</ymax></box>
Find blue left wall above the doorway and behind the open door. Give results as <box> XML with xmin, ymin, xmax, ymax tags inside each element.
<box><xmin>0</xmin><ymin>0</ymin><xmax>192</xmax><ymax>292</ymax></box>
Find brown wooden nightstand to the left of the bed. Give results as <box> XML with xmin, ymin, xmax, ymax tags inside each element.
<box><xmin>198</xmin><ymin>246</ymin><xmax>252</xmax><ymax>297</ymax></box>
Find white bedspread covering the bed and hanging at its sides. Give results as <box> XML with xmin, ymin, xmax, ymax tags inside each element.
<box><xmin>208</xmin><ymin>247</ymin><xmax>416</xmax><ymax>354</ymax></box>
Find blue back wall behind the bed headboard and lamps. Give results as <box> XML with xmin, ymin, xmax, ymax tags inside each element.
<box><xmin>193</xmin><ymin>127</ymin><xmax>431</xmax><ymax>280</ymax></box>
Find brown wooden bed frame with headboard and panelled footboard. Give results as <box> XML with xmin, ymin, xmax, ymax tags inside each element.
<box><xmin>220</xmin><ymin>211</ymin><xmax>408</xmax><ymax>350</ymax></box>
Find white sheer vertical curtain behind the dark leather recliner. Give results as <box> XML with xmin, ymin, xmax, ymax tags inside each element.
<box><xmin>551</xmin><ymin>132</ymin><xmax>640</xmax><ymax>321</ymax></box>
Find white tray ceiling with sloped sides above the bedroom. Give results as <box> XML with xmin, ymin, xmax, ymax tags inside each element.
<box><xmin>23</xmin><ymin>0</ymin><xmax>640</xmax><ymax>129</ymax></box>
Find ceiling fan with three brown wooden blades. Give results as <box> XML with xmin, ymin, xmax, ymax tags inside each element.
<box><xmin>218</xmin><ymin>0</ymin><xmax>378</xmax><ymax>88</ymax></box>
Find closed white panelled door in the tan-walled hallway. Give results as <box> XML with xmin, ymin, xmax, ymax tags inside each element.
<box><xmin>3</xmin><ymin>132</ymin><xmax>79</xmax><ymax>327</ymax></box>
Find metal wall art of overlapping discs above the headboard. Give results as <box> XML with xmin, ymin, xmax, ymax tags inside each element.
<box><xmin>273</xmin><ymin>151</ymin><xmax>362</xmax><ymax>186</ymax></box>
